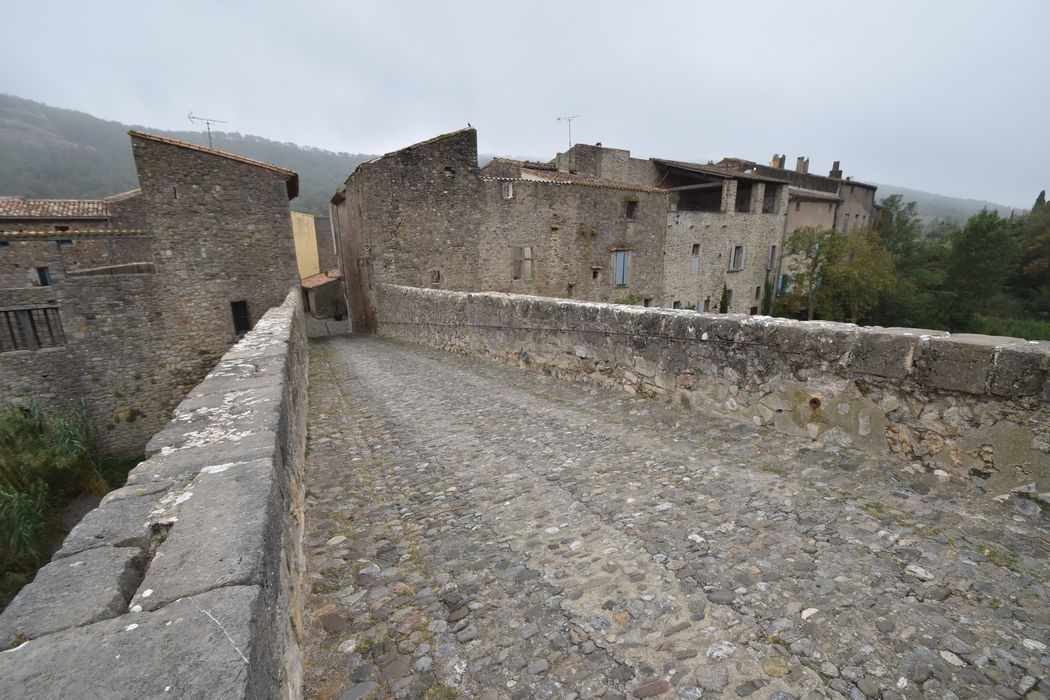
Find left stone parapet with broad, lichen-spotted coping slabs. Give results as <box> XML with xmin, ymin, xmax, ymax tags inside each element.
<box><xmin>0</xmin><ymin>290</ymin><xmax>309</xmax><ymax>698</ymax></box>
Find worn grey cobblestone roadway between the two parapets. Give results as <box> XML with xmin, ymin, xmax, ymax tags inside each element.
<box><xmin>305</xmin><ymin>337</ymin><xmax>1050</xmax><ymax>700</ymax></box>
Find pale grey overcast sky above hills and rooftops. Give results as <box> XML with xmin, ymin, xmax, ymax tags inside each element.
<box><xmin>0</xmin><ymin>0</ymin><xmax>1050</xmax><ymax>208</ymax></box>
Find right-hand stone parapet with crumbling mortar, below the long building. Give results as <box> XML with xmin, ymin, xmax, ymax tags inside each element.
<box><xmin>376</xmin><ymin>284</ymin><xmax>1050</xmax><ymax>490</ymax></box>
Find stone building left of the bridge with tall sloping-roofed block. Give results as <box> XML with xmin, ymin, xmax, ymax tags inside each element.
<box><xmin>0</xmin><ymin>131</ymin><xmax>298</xmax><ymax>455</ymax></box>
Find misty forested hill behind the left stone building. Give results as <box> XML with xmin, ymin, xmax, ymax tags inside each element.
<box><xmin>0</xmin><ymin>94</ymin><xmax>374</xmax><ymax>214</ymax></box>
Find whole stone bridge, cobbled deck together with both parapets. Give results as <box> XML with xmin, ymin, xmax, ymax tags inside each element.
<box><xmin>0</xmin><ymin>288</ymin><xmax>1050</xmax><ymax>700</ymax></box>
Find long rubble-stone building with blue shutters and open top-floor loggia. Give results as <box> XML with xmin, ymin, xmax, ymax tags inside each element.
<box><xmin>332</xmin><ymin>129</ymin><xmax>852</xmax><ymax>328</ymax></box>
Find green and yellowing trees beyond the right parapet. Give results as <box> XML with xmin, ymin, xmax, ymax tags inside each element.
<box><xmin>777</xmin><ymin>192</ymin><xmax>1050</xmax><ymax>340</ymax></box>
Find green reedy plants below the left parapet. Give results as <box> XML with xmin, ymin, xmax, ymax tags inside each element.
<box><xmin>0</xmin><ymin>402</ymin><xmax>133</xmax><ymax>610</ymax></box>
